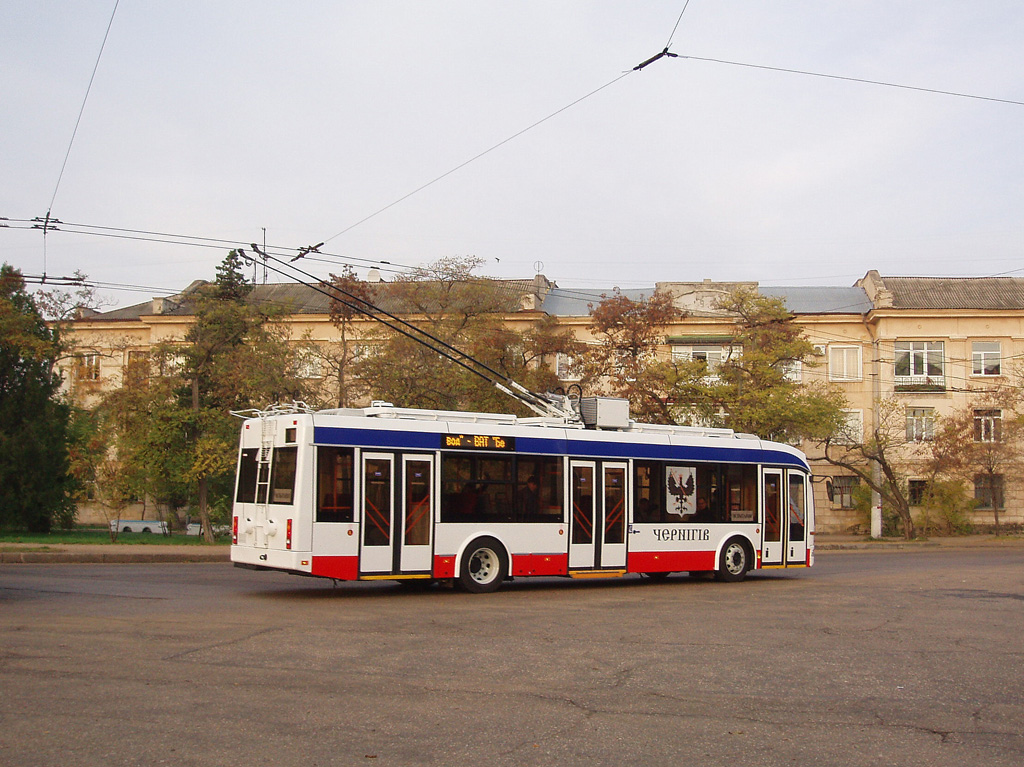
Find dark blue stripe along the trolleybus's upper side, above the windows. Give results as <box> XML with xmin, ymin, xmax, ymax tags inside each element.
<box><xmin>313</xmin><ymin>426</ymin><xmax>809</xmax><ymax>469</ymax></box>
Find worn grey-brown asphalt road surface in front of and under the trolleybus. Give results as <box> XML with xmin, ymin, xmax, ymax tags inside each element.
<box><xmin>0</xmin><ymin>547</ymin><xmax>1024</xmax><ymax>767</ymax></box>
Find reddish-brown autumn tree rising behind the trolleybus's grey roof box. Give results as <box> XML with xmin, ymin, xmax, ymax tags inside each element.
<box><xmin>584</xmin><ymin>290</ymin><xmax>684</xmax><ymax>424</ymax></box>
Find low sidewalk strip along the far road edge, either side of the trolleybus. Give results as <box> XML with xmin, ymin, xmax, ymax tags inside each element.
<box><xmin>0</xmin><ymin>535</ymin><xmax>1024</xmax><ymax>564</ymax></box>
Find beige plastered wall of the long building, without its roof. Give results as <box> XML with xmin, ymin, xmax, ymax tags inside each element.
<box><xmin>61</xmin><ymin>278</ymin><xmax>1024</xmax><ymax>532</ymax></box>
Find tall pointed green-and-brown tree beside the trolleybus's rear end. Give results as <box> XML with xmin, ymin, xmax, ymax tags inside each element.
<box><xmin>102</xmin><ymin>251</ymin><xmax>304</xmax><ymax>541</ymax></box>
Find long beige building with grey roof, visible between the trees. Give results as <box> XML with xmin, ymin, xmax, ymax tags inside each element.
<box><xmin>62</xmin><ymin>271</ymin><xmax>1024</xmax><ymax>532</ymax></box>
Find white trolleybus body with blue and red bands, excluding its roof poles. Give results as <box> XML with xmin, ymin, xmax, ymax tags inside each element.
<box><xmin>231</xmin><ymin>398</ymin><xmax>814</xmax><ymax>592</ymax></box>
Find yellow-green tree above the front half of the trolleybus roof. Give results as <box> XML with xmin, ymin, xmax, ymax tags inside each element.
<box><xmin>670</xmin><ymin>288</ymin><xmax>846</xmax><ymax>442</ymax></box>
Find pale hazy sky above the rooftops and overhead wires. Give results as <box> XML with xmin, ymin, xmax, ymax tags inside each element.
<box><xmin>0</xmin><ymin>0</ymin><xmax>1024</xmax><ymax>305</ymax></box>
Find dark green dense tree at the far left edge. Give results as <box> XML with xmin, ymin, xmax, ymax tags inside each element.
<box><xmin>0</xmin><ymin>264</ymin><xmax>75</xmax><ymax>531</ymax></box>
